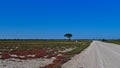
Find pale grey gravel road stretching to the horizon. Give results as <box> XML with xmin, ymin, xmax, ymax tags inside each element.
<box><xmin>62</xmin><ymin>41</ymin><xmax>120</xmax><ymax>68</ymax></box>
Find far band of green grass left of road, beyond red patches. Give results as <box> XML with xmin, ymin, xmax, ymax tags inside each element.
<box><xmin>0</xmin><ymin>40</ymin><xmax>91</xmax><ymax>54</ymax></box>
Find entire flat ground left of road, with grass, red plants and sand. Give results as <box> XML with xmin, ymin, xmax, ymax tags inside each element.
<box><xmin>0</xmin><ymin>40</ymin><xmax>91</xmax><ymax>68</ymax></box>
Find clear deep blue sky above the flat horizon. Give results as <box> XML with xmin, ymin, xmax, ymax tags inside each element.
<box><xmin>0</xmin><ymin>0</ymin><xmax>120</xmax><ymax>39</ymax></box>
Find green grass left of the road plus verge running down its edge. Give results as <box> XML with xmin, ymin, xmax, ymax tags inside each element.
<box><xmin>0</xmin><ymin>40</ymin><xmax>92</xmax><ymax>68</ymax></box>
